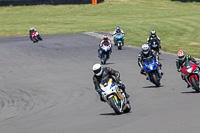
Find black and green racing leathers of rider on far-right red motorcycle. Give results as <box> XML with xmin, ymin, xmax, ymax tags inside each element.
<box><xmin>176</xmin><ymin>55</ymin><xmax>200</xmax><ymax>88</ymax></box>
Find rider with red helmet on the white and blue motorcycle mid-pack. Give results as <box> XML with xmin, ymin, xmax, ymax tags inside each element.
<box><xmin>98</xmin><ymin>35</ymin><xmax>112</xmax><ymax>57</ymax></box>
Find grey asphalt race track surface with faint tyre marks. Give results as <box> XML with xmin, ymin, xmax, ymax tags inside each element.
<box><xmin>0</xmin><ymin>33</ymin><xmax>200</xmax><ymax>133</ymax></box>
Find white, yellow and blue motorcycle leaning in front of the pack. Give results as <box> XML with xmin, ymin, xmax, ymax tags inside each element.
<box><xmin>100</xmin><ymin>78</ymin><xmax>131</xmax><ymax>114</ymax></box>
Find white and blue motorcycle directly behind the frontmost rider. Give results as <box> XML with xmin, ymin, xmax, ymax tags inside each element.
<box><xmin>99</xmin><ymin>44</ymin><xmax>111</xmax><ymax>64</ymax></box>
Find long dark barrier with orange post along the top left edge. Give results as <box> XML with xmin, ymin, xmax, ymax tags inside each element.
<box><xmin>0</xmin><ymin>0</ymin><xmax>104</xmax><ymax>6</ymax></box>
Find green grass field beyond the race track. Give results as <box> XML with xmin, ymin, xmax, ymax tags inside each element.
<box><xmin>0</xmin><ymin>0</ymin><xmax>200</xmax><ymax>58</ymax></box>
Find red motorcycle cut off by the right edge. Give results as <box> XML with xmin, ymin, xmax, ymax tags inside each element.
<box><xmin>182</xmin><ymin>61</ymin><xmax>200</xmax><ymax>92</ymax></box>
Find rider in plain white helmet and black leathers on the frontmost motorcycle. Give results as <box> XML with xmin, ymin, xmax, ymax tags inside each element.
<box><xmin>92</xmin><ymin>64</ymin><xmax>129</xmax><ymax>102</ymax></box>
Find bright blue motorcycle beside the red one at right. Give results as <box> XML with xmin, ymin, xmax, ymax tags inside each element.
<box><xmin>144</xmin><ymin>58</ymin><xmax>161</xmax><ymax>87</ymax></box>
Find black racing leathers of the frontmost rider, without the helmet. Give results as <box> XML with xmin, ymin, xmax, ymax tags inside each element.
<box><xmin>93</xmin><ymin>67</ymin><xmax>129</xmax><ymax>101</ymax></box>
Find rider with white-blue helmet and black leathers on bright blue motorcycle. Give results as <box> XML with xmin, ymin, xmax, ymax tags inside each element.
<box><xmin>138</xmin><ymin>44</ymin><xmax>163</xmax><ymax>80</ymax></box>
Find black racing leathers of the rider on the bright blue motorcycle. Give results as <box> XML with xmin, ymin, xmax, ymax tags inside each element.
<box><xmin>138</xmin><ymin>49</ymin><xmax>163</xmax><ymax>79</ymax></box>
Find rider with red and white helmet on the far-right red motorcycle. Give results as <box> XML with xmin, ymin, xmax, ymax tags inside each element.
<box><xmin>176</xmin><ymin>50</ymin><xmax>200</xmax><ymax>88</ymax></box>
